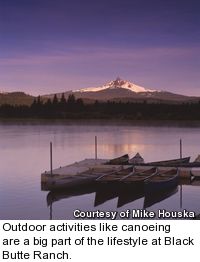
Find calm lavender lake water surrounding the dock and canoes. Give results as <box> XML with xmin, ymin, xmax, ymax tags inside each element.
<box><xmin>0</xmin><ymin>122</ymin><xmax>200</xmax><ymax>219</ymax></box>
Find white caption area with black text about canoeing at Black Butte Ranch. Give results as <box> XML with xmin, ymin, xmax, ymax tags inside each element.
<box><xmin>0</xmin><ymin>220</ymin><xmax>200</xmax><ymax>262</ymax></box>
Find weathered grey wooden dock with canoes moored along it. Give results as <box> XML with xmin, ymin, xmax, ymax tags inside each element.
<box><xmin>41</xmin><ymin>159</ymin><xmax>200</xmax><ymax>191</ymax></box>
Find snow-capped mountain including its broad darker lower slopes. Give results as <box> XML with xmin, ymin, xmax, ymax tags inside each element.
<box><xmin>44</xmin><ymin>77</ymin><xmax>197</xmax><ymax>103</ymax></box>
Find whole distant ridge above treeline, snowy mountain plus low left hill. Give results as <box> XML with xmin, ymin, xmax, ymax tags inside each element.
<box><xmin>0</xmin><ymin>77</ymin><xmax>200</xmax><ymax>105</ymax></box>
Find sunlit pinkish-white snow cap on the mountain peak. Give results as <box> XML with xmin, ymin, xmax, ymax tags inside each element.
<box><xmin>74</xmin><ymin>77</ymin><xmax>158</xmax><ymax>93</ymax></box>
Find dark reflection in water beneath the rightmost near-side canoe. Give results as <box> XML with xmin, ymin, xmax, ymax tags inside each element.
<box><xmin>143</xmin><ymin>186</ymin><xmax>178</xmax><ymax>209</ymax></box>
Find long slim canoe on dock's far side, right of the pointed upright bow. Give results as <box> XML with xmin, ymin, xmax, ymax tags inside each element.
<box><xmin>138</xmin><ymin>157</ymin><xmax>190</xmax><ymax>167</ymax></box>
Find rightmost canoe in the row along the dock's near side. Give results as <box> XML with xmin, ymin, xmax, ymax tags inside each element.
<box><xmin>144</xmin><ymin>168</ymin><xmax>178</xmax><ymax>194</ymax></box>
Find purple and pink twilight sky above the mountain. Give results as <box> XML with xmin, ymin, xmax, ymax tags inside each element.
<box><xmin>0</xmin><ymin>0</ymin><xmax>200</xmax><ymax>96</ymax></box>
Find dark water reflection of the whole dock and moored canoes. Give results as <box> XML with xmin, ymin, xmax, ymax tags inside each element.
<box><xmin>46</xmin><ymin>179</ymin><xmax>200</xmax><ymax>219</ymax></box>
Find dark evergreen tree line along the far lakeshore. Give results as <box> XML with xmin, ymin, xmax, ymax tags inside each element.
<box><xmin>0</xmin><ymin>94</ymin><xmax>200</xmax><ymax>120</ymax></box>
